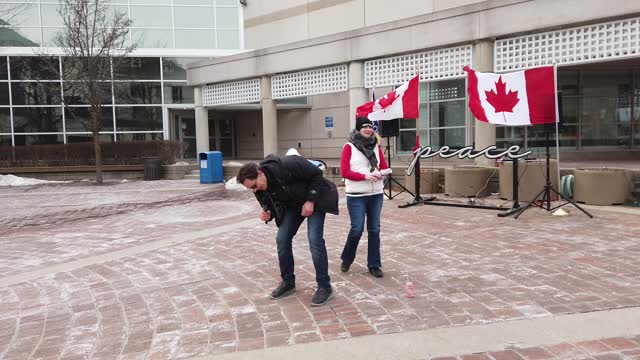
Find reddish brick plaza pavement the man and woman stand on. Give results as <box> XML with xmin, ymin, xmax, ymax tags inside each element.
<box><xmin>0</xmin><ymin>181</ymin><xmax>640</xmax><ymax>359</ymax></box>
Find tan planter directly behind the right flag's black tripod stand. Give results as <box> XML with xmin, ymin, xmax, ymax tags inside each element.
<box><xmin>500</xmin><ymin>159</ymin><xmax>560</xmax><ymax>201</ymax></box>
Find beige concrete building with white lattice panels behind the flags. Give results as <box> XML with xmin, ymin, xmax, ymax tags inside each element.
<box><xmin>187</xmin><ymin>0</ymin><xmax>640</xmax><ymax>159</ymax></box>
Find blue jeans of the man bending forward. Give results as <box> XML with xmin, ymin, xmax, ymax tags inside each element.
<box><xmin>276</xmin><ymin>208</ymin><xmax>331</xmax><ymax>288</ymax></box>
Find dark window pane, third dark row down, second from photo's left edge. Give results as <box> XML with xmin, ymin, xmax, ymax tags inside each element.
<box><xmin>13</xmin><ymin>107</ymin><xmax>62</xmax><ymax>133</ymax></box>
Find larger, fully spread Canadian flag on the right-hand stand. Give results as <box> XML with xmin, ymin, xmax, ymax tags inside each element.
<box><xmin>464</xmin><ymin>66</ymin><xmax>557</xmax><ymax>126</ymax></box>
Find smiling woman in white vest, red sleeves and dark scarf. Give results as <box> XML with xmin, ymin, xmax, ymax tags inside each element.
<box><xmin>340</xmin><ymin>117</ymin><xmax>389</xmax><ymax>278</ymax></box>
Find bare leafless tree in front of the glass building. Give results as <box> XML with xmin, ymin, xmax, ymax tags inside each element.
<box><xmin>49</xmin><ymin>0</ymin><xmax>135</xmax><ymax>184</ymax></box>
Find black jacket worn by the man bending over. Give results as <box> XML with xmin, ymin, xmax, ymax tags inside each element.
<box><xmin>255</xmin><ymin>155</ymin><xmax>338</xmax><ymax>226</ymax></box>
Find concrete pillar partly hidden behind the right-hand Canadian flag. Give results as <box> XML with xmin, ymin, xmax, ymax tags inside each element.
<box><xmin>471</xmin><ymin>40</ymin><xmax>496</xmax><ymax>166</ymax></box>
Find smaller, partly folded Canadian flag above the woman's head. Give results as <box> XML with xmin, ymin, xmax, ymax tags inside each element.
<box><xmin>356</xmin><ymin>76</ymin><xmax>419</xmax><ymax>121</ymax></box>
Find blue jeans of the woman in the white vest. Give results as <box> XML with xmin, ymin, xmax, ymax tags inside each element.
<box><xmin>340</xmin><ymin>194</ymin><xmax>384</xmax><ymax>268</ymax></box>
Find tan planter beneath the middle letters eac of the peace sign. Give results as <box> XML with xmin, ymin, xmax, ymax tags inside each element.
<box><xmin>444</xmin><ymin>165</ymin><xmax>496</xmax><ymax>197</ymax></box>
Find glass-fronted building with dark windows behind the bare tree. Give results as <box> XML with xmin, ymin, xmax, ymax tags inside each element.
<box><xmin>0</xmin><ymin>0</ymin><xmax>244</xmax><ymax>157</ymax></box>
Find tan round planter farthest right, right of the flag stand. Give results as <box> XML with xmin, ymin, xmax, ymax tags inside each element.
<box><xmin>573</xmin><ymin>168</ymin><xmax>632</xmax><ymax>205</ymax></box>
